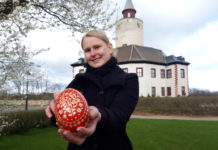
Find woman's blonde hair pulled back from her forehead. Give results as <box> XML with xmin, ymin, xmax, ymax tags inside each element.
<box><xmin>81</xmin><ymin>30</ymin><xmax>114</xmax><ymax>56</ymax></box>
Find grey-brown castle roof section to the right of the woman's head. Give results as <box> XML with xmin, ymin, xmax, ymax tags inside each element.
<box><xmin>116</xmin><ymin>45</ymin><xmax>189</xmax><ymax>65</ymax></box>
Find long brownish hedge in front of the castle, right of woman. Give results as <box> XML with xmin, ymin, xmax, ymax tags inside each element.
<box><xmin>135</xmin><ymin>96</ymin><xmax>218</xmax><ymax>116</ymax></box>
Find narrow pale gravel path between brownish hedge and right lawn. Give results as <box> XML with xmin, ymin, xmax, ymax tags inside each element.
<box><xmin>131</xmin><ymin>115</ymin><xmax>218</xmax><ymax>121</ymax></box>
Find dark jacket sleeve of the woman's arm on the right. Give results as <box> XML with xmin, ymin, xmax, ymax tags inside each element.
<box><xmin>97</xmin><ymin>74</ymin><xmax>139</xmax><ymax>132</ymax></box>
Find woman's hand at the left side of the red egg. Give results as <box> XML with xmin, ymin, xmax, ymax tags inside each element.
<box><xmin>45</xmin><ymin>92</ymin><xmax>61</xmax><ymax>118</ymax></box>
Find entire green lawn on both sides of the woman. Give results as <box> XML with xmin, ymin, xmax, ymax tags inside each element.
<box><xmin>0</xmin><ymin>119</ymin><xmax>218</xmax><ymax>150</ymax></box>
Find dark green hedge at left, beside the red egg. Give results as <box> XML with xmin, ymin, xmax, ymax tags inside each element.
<box><xmin>0</xmin><ymin>110</ymin><xmax>51</xmax><ymax>136</ymax></box>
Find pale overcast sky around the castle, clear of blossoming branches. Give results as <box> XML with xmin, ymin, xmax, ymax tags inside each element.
<box><xmin>28</xmin><ymin>0</ymin><xmax>218</xmax><ymax>91</ymax></box>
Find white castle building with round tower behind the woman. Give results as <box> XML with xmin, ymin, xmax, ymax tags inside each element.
<box><xmin>71</xmin><ymin>0</ymin><xmax>190</xmax><ymax>97</ymax></box>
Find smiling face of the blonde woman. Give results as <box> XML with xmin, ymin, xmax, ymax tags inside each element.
<box><xmin>82</xmin><ymin>37</ymin><xmax>113</xmax><ymax>68</ymax></box>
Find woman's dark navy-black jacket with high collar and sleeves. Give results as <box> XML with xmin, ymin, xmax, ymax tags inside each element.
<box><xmin>67</xmin><ymin>58</ymin><xmax>139</xmax><ymax>150</ymax></box>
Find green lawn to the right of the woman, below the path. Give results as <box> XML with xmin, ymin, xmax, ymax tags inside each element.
<box><xmin>128</xmin><ymin>119</ymin><xmax>218</xmax><ymax>150</ymax></box>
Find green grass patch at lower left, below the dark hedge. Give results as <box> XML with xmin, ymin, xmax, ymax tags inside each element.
<box><xmin>0</xmin><ymin>127</ymin><xmax>67</xmax><ymax>150</ymax></box>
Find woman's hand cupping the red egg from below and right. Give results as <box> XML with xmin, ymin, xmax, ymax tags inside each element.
<box><xmin>58</xmin><ymin>106</ymin><xmax>101</xmax><ymax>145</ymax></box>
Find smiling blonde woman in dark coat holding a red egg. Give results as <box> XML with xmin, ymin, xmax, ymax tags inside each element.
<box><xmin>46</xmin><ymin>30</ymin><xmax>139</xmax><ymax>150</ymax></box>
